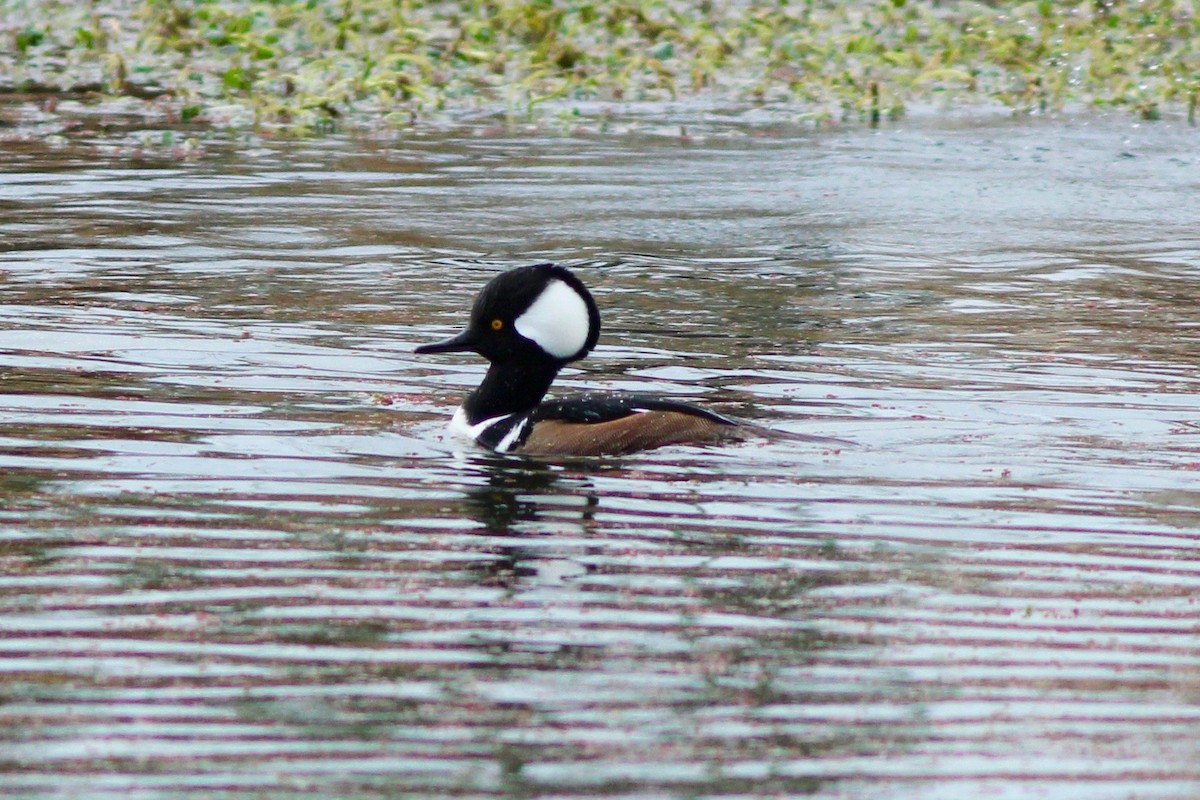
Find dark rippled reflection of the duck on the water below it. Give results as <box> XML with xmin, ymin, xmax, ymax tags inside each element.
<box><xmin>463</xmin><ymin>455</ymin><xmax>600</xmax><ymax>588</ymax></box>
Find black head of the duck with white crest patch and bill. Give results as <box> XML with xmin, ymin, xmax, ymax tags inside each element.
<box><xmin>415</xmin><ymin>264</ymin><xmax>600</xmax><ymax>366</ymax></box>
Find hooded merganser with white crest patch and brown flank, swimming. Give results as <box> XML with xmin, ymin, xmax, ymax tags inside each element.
<box><xmin>415</xmin><ymin>264</ymin><xmax>746</xmax><ymax>456</ymax></box>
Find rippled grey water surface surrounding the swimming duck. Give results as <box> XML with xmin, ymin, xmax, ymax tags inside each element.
<box><xmin>0</xmin><ymin>113</ymin><xmax>1200</xmax><ymax>800</ymax></box>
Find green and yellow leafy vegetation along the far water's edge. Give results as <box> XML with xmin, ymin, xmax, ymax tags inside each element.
<box><xmin>0</xmin><ymin>0</ymin><xmax>1200</xmax><ymax>134</ymax></box>
